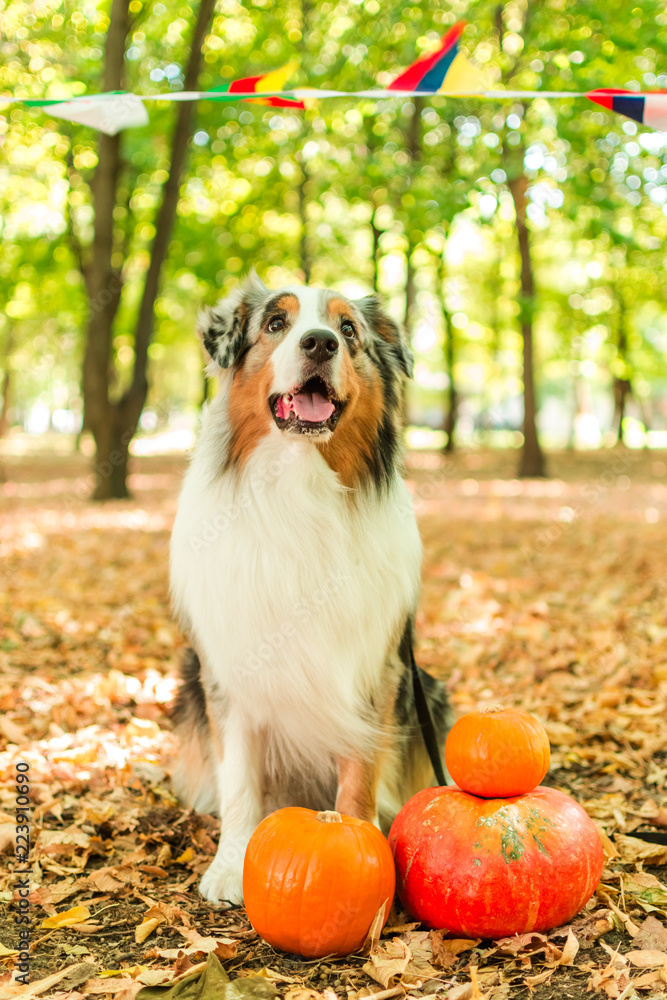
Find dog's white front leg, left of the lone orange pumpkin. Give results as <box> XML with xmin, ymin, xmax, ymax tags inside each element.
<box><xmin>199</xmin><ymin>713</ymin><xmax>263</xmax><ymax>903</ymax></box>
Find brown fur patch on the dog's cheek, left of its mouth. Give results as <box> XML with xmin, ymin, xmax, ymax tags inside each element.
<box><xmin>227</xmin><ymin>332</ymin><xmax>276</xmax><ymax>468</ymax></box>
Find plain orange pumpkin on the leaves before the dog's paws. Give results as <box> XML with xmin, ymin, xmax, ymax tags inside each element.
<box><xmin>243</xmin><ymin>808</ymin><xmax>396</xmax><ymax>958</ymax></box>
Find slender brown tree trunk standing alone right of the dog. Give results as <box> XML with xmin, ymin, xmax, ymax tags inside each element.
<box><xmin>507</xmin><ymin>173</ymin><xmax>546</xmax><ymax>478</ymax></box>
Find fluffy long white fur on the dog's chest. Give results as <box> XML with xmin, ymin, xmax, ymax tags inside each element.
<box><xmin>171</xmin><ymin>402</ymin><xmax>421</xmax><ymax>759</ymax></box>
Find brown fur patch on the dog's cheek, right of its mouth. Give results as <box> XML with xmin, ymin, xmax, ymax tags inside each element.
<box><xmin>317</xmin><ymin>353</ymin><xmax>384</xmax><ymax>488</ymax></box>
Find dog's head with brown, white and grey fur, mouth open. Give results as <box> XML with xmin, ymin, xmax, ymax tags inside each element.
<box><xmin>200</xmin><ymin>275</ymin><xmax>412</xmax><ymax>490</ymax></box>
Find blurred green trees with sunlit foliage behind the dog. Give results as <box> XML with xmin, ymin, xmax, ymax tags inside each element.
<box><xmin>0</xmin><ymin>0</ymin><xmax>667</xmax><ymax>497</ymax></box>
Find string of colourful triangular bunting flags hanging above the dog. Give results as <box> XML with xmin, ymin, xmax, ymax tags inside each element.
<box><xmin>0</xmin><ymin>21</ymin><xmax>667</xmax><ymax>135</ymax></box>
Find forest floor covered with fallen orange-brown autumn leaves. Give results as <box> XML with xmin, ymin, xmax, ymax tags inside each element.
<box><xmin>0</xmin><ymin>448</ymin><xmax>667</xmax><ymax>1000</ymax></box>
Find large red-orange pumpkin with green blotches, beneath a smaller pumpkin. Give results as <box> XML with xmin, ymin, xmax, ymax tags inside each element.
<box><xmin>389</xmin><ymin>788</ymin><xmax>603</xmax><ymax>938</ymax></box>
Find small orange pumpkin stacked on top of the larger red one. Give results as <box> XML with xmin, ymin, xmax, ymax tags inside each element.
<box><xmin>445</xmin><ymin>707</ymin><xmax>550</xmax><ymax>799</ymax></box>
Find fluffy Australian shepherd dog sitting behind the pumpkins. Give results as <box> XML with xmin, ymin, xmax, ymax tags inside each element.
<box><xmin>171</xmin><ymin>274</ymin><xmax>447</xmax><ymax>904</ymax></box>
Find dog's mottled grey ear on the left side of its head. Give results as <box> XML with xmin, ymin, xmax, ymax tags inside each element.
<box><xmin>197</xmin><ymin>271</ymin><xmax>268</xmax><ymax>368</ymax></box>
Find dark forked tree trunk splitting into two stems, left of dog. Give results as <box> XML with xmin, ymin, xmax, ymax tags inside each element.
<box><xmin>83</xmin><ymin>0</ymin><xmax>215</xmax><ymax>500</ymax></box>
